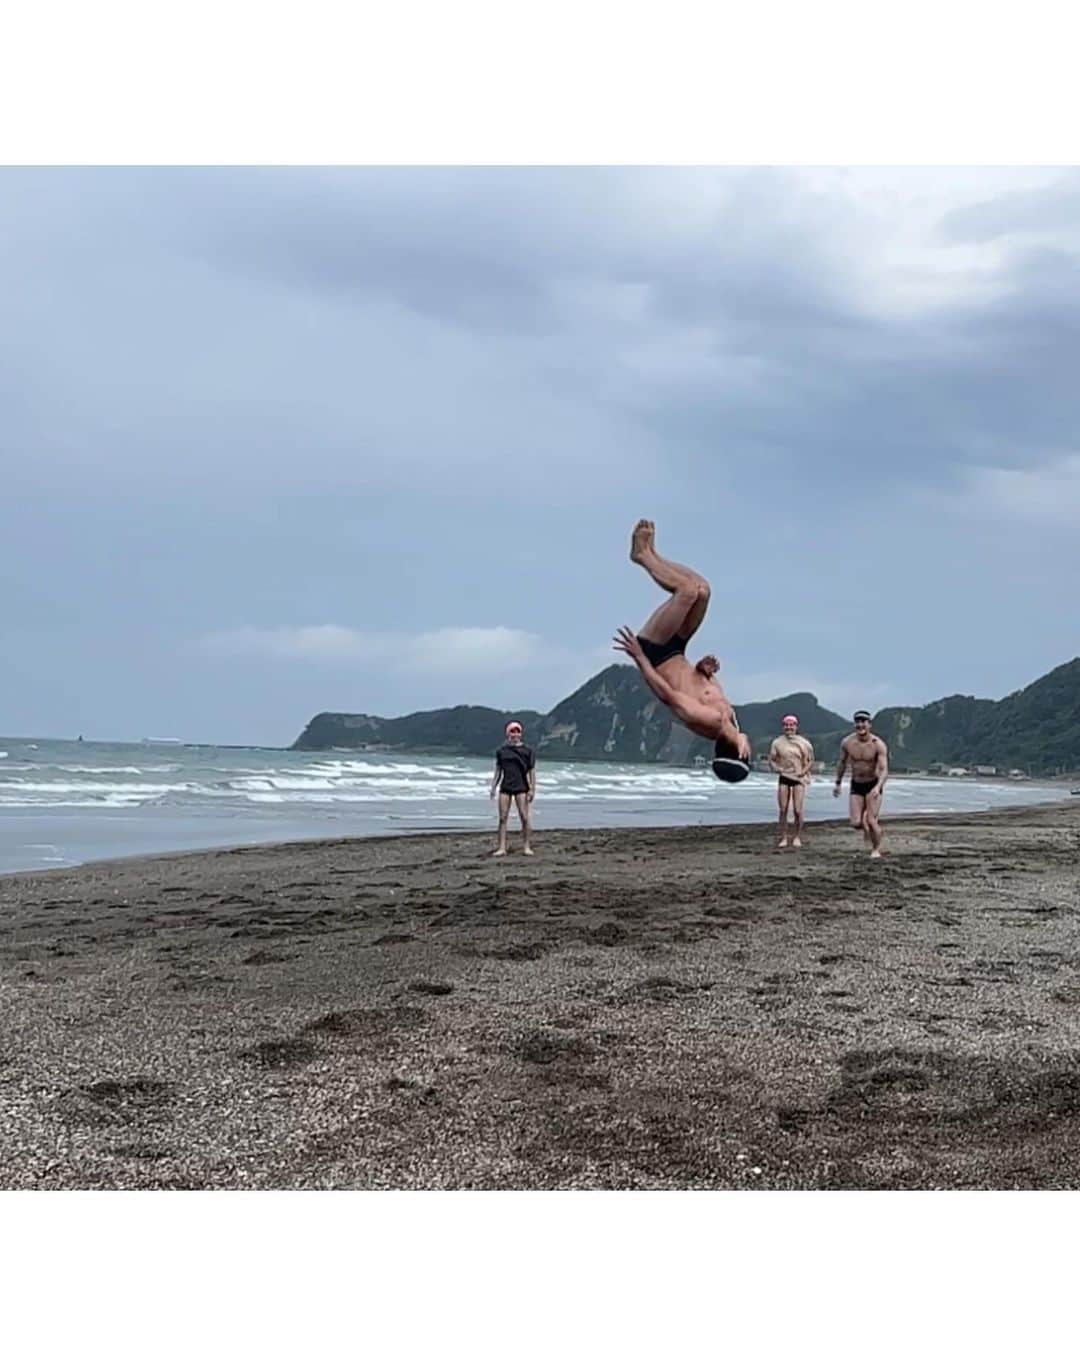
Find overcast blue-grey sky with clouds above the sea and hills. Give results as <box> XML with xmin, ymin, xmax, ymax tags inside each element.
<box><xmin>0</xmin><ymin>167</ymin><xmax>1080</xmax><ymax>745</ymax></box>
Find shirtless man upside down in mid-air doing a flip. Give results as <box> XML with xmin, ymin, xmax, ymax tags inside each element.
<box><xmin>614</xmin><ymin>520</ymin><xmax>751</xmax><ymax>783</ymax></box>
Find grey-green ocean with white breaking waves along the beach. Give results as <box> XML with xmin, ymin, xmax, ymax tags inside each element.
<box><xmin>0</xmin><ymin>740</ymin><xmax>1068</xmax><ymax>872</ymax></box>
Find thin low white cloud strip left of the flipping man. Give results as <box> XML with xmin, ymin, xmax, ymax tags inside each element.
<box><xmin>200</xmin><ymin>624</ymin><xmax>547</xmax><ymax>675</ymax></box>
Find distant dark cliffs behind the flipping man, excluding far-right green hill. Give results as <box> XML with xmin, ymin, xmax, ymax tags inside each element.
<box><xmin>292</xmin><ymin>664</ymin><xmax>849</xmax><ymax>764</ymax></box>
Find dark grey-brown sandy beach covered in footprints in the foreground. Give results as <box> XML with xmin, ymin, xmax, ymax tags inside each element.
<box><xmin>0</xmin><ymin>803</ymin><xmax>1080</xmax><ymax>1189</ymax></box>
